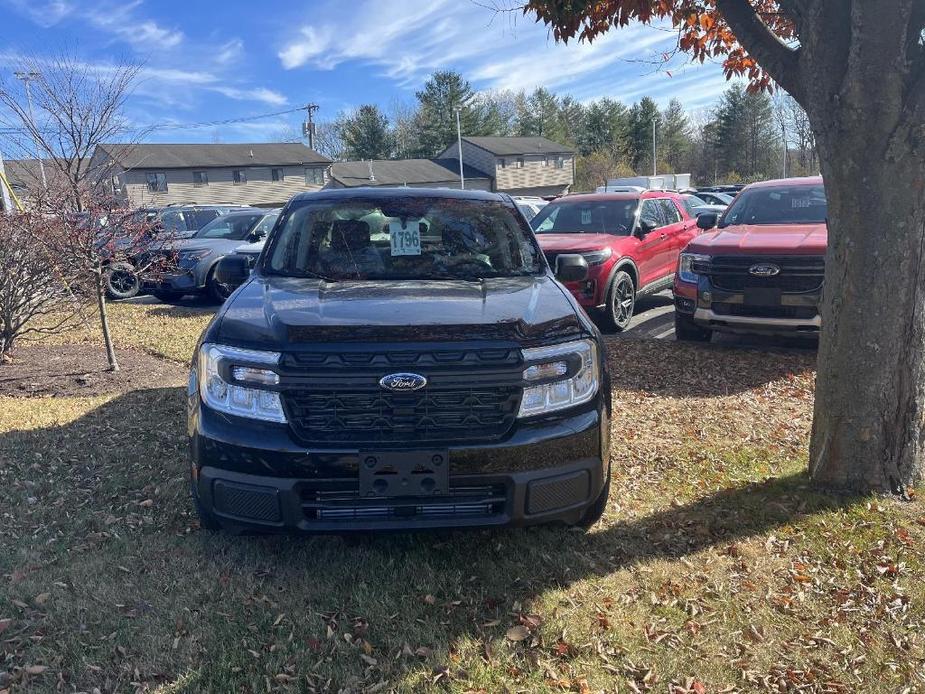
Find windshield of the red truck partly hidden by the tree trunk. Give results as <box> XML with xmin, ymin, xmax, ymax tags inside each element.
<box><xmin>719</xmin><ymin>184</ymin><xmax>828</xmax><ymax>227</ymax></box>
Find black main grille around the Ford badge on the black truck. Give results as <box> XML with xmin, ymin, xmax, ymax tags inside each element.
<box><xmin>282</xmin><ymin>348</ymin><xmax>523</xmax><ymax>446</ymax></box>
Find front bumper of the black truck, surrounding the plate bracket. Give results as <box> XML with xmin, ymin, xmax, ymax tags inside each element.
<box><xmin>190</xmin><ymin>396</ymin><xmax>609</xmax><ymax>533</ymax></box>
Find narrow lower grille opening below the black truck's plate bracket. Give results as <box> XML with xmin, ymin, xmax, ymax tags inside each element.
<box><xmin>299</xmin><ymin>480</ymin><xmax>507</xmax><ymax>522</ymax></box>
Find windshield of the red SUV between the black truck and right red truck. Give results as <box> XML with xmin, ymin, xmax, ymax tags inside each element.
<box><xmin>530</xmin><ymin>198</ymin><xmax>639</xmax><ymax>236</ymax></box>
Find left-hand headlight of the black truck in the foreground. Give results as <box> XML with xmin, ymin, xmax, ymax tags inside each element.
<box><xmin>199</xmin><ymin>343</ymin><xmax>286</xmax><ymax>424</ymax></box>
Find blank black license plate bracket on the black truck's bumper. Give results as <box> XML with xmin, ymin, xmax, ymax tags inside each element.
<box><xmin>360</xmin><ymin>450</ymin><xmax>450</xmax><ymax>497</ymax></box>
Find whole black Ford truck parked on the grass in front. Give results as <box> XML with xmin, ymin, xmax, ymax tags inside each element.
<box><xmin>188</xmin><ymin>188</ymin><xmax>610</xmax><ymax>533</ymax></box>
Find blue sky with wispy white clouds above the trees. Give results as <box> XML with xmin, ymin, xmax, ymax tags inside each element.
<box><xmin>0</xmin><ymin>0</ymin><xmax>727</xmax><ymax>142</ymax></box>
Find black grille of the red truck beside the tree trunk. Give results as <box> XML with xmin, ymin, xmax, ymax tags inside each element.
<box><xmin>693</xmin><ymin>255</ymin><xmax>825</xmax><ymax>294</ymax></box>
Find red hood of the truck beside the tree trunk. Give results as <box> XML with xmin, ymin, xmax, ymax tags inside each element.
<box><xmin>686</xmin><ymin>224</ymin><xmax>827</xmax><ymax>255</ymax></box>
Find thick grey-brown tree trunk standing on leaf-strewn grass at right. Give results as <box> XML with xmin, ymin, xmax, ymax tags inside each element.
<box><xmin>804</xmin><ymin>0</ymin><xmax>925</xmax><ymax>494</ymax></box>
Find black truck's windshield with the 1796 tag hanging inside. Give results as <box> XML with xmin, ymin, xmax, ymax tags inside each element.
<box><xmin>262</xmin><ymin>196</ymin><xmax>545</xmax><ymax>281</ymax></box>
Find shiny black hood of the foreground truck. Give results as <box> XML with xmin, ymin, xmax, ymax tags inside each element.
<box><xmin>217</xmin><ymin>276</ymin><xmax>584</xmax><ymax>350</ymax></box>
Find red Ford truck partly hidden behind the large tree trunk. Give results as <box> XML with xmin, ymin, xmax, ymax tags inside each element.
<box><xmin>674</xmin><ymin>176</ymin><xmax>827</xmax><ymax>341</ymax></box>
